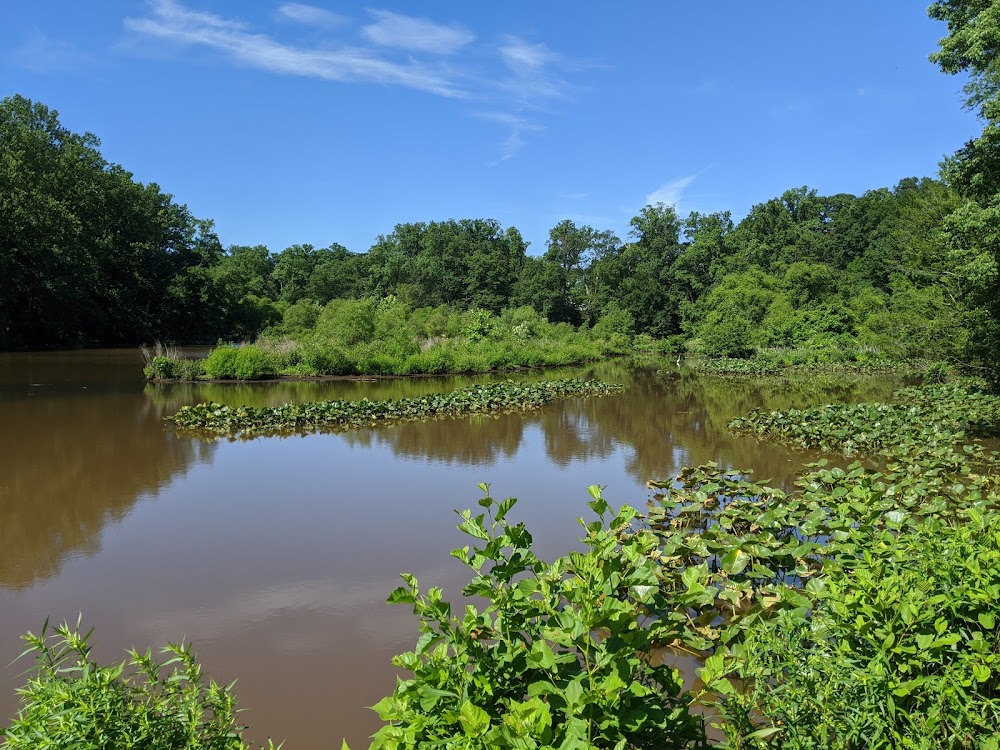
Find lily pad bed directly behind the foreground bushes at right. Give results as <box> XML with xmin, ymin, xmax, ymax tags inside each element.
<box><xmin>619</xmin><ymin>460</ymin><xmax>1000</xmax><ymax>653</ymax></box>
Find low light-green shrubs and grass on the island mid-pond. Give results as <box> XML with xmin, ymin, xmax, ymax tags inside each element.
<box><xmin>146</xmin><ymin>297</ymin><xmax>634</xmax><ymax>380</ymax></box>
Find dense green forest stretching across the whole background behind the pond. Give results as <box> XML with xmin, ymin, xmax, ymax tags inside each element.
<box><xmin>0</xmin><ymin>4</ymin><xmax>1000</xmax><ymax>382</ymax></box>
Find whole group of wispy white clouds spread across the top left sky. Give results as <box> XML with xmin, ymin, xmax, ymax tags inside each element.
<box><xmin>124</xmin><ymin>0</ymin><xmax>595</xmax><ymax>164</ymax></box>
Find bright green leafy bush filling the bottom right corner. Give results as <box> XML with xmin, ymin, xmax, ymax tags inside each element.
<box><xmin>728</xmin><ymin>508</ymin><xmax>1000</xmax><ymax>750</ymax></box>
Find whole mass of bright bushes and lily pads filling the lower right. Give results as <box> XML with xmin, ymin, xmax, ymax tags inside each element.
<box><xmin>360</xmin><ymin>374</ymin><xmax>1000</xmax><ymax>750</ymax></box>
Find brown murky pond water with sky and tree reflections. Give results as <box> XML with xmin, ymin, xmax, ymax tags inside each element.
<box><xmin>0</xmin><ymin>350</ymin><xmax>898</xmax><ymax>750</ymax></box>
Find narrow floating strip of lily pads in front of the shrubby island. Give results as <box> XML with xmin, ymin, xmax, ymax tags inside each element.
<box><xmin>168</xmin><ymin>379</ymin><xmax>623</xmax><ymax>437</ymax></box>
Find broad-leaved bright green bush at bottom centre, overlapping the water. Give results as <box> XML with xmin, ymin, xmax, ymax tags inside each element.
<box><xmin>352</xmin><ymin>485</ymin><xmax>705</xmax><ymax>750</ymax></box>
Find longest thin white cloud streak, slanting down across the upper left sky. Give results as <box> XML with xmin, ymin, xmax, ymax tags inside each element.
<box><xmin>125</xmin><ymin>0</ymin><xmax>465</xmax><ymax>97</ymax></box>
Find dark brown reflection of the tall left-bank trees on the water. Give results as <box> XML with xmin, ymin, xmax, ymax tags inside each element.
<box><xmin>0</xmin><ymin>353</ymin><xmax>215</xmax><ymax>589</ymax></box>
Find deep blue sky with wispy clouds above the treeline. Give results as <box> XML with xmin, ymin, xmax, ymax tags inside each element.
<box><xmin>0</xmin><ymin>0</ymin><xmax>980</xmax><ymax>254</ymax></box>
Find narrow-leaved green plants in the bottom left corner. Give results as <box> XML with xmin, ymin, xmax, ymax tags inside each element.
<box><xmin>0</xmin><ymin>621</ymin><xmax>274</xmax><ymax>750</ymax></box>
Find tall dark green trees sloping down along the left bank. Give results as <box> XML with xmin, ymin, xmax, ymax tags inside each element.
<box><xmin>0</xmin><ymin>96</ymin><xmax>215</xmax><ymax>348</ymax></box>
